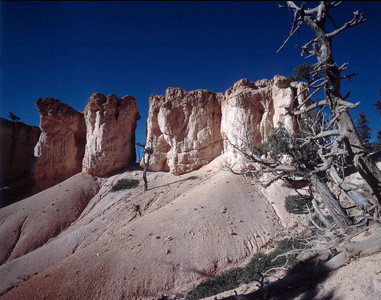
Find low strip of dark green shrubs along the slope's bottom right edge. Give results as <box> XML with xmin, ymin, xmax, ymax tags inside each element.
<box><xmin>186</xmin><ymin>239</ymin><xmax>304</xmax><ymax>300</ymax></box>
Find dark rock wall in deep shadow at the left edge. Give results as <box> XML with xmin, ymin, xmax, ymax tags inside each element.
<box><xmin>0</xmin><ymin>118</ymin><xmax>41</xmax><ymax>207</ymax></box>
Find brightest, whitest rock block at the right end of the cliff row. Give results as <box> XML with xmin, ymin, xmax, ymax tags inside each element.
<box><xmin>221</xmin><ymin>75</ymin><xmax>308</xmax><ymax>164</ymax></box>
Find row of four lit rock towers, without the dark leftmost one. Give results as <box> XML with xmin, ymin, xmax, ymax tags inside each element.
<box><xmin>29</xmin><ymin>75</ymin><xmax>308</xmax><ymax>190</ymax></box>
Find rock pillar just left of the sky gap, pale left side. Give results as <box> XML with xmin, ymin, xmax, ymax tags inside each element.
<box><xmin>82</xmin><ymin>93</ymin><xmax>140</xmax><ymax>176</ymax></box>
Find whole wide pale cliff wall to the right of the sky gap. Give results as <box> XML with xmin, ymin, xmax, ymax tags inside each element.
<box><xmin>146</xmin><ymin>75</ymin><xmax>308</xmax><ymax>174</ymax></box>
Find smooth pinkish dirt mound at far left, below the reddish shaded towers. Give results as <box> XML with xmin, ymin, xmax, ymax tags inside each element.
<box><xmin>0</xmin><ymin>174</ymin><xmax>100</xmax><ymax>263</ymax></box>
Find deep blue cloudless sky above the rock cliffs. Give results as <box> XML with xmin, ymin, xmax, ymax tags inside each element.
<box><xmin>0</xmin><ymin>1</ymin><xmax>381</xmax><ymax>142</ymax></box>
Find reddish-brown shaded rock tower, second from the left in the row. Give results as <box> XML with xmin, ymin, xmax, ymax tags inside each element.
<box><xmin>34</xmin><ymin>98</ymin><xmax>86</xmax><ymax>189</ymax></box>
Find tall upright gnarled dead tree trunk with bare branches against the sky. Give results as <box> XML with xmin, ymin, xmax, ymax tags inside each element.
<box><xmin>278</xmin><ymin>1</ymin><xmax>381</xmax><ymax>203</ymax></box>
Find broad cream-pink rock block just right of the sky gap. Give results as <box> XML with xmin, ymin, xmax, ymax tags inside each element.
<box><xmin>146</xmin><ymin>88</ymin><xmax>223</xmax><ymax>175</ymax></box>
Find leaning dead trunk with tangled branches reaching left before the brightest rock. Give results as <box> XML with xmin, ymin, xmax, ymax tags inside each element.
<box><xmin>229</xmin><ymin>124</ymin><xmax>351</xmax><ymax>231</ymax></box>
